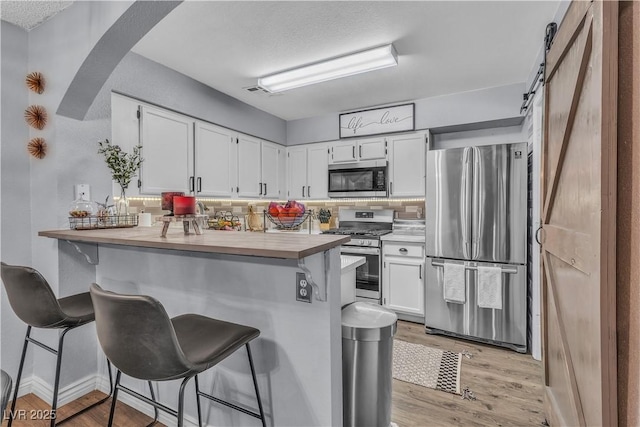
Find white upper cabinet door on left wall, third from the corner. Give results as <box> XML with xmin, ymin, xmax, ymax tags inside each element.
<box><xmin>195</xmin><ymin>122</ymin><xmax>237</xmax><ymax>197</ymax></box>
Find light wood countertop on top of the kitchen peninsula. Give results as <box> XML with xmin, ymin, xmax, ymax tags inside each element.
<box><xmin>38</xmin><ymin>227</ymin><xmax>350</xmax><ymax>259</ymax></box>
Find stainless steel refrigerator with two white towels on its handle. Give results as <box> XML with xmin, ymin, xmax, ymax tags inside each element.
<box><xmin>425</xmin><ymin>142</ymin><xmax>527</xmax><ymax>352</ymax></box>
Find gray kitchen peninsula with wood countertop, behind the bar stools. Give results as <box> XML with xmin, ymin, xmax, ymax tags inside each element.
<box><xmin>39</xmin><ymin>227</ymin><xmax>349</xmax><ymax>426</ymax></box>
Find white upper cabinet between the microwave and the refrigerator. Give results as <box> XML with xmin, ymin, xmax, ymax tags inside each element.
<box><xmin>387</xmin><ymin>132</ymin><xmax>427</xmax><ymax>197</ymax></box>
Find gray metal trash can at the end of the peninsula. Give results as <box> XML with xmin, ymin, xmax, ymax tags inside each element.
<box><xmin>342</xmin><ymin>302</ymin><xmax>398</xmax><ymax>427</ymax></box>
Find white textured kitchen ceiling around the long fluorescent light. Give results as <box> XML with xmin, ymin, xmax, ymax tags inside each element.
<box><xmin>133</xmin><ymin>0</ymin><xmax>560</xmax><ymax>120</ymax></box>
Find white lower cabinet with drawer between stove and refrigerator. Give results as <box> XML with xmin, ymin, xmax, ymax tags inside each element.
<box><xmin>382</xmin><ymin>242</ymin><xmax>425</xmax><ymax>317</ymax></box>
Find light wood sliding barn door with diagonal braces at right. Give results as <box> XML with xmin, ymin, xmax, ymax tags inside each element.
<box><xmin>540</xmin><ymin>1</ymin><xmax>618</xmax><ymax>426</ymax></box>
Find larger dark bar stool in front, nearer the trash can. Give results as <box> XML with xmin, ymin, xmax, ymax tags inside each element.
<box><xmin>90</xmin><ymin>283</ymin><xmax>266</xmax><ymax>427</ymax></box>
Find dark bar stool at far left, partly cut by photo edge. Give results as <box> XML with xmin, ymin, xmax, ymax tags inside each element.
<box><xmin>1</xmin><ymin>262</ymin><xmax>119</xmax><ymax>427</ymax></box>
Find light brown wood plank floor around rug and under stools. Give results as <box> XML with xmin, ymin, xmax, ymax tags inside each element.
<box><xmin>2</xmin><ymin>321</ymin><xmax>545</xmax><ymax>427</ymax></box>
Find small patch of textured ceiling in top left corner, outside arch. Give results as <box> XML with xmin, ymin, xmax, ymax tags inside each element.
<box><xmin>0</xmin><ymin>0</ymin><xmax>73</xmax><ymax>31</ymax></box>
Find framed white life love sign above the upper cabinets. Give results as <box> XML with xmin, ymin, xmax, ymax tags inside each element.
<box><xmin>340</xmin><ymin>104</ymin><xmax>415</xmax><ymax>138</ymax></box>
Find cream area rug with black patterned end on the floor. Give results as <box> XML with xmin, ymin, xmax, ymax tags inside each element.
<box><xmin>393</xmin><ymin>339</ymin><xmax>462</xmax><ymax>394</ymax></box>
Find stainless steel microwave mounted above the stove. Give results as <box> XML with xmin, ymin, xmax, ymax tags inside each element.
<box><xmin>329</xmin><ymin>160</ymin><xmax>388</xmax><ymax>197</ymax></box>
